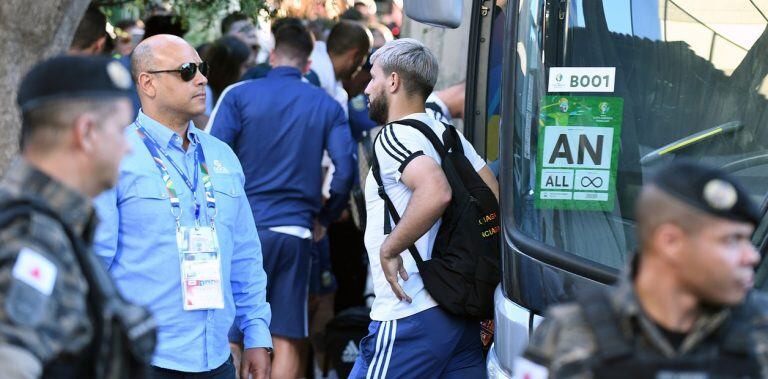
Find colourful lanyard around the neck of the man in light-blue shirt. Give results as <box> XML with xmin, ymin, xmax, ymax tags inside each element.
<box><xmin>135</xmin><ymin>120</ymin><xmax>216</xmax><ymax>226</ymax></box>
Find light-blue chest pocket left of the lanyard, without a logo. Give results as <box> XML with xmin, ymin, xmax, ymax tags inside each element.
<box><xmin>120</xmin><ymin>176</ymin><xmax>176</xmax><ymax>234</ymax></box>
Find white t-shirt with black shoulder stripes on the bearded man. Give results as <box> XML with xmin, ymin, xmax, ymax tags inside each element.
<box><xmin>365</xmin><ymin>113</ymin><xmax>485</xmax><ymax>321</ymax></box>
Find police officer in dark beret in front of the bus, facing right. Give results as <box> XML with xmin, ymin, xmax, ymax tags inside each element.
<box><xmin>515</xmin><ymin>161</ymin><xmax>768</xmax><ymax>378</ymax></box>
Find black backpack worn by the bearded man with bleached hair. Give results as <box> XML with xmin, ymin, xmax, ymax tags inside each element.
<box><xmin>371</xmin><ymin>119</ymin><xmax>501</xmax><ymax>319</ymax></box>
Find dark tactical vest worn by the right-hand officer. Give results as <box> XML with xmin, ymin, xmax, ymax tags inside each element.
<box><xmin>576</xmin><ymin>289</ymin><xmax>761</xmax><ymax>379</ymax></box>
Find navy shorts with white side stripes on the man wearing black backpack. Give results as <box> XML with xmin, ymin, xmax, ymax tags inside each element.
<box><xmin>349</xmin><ymin>307</ymin><xmax>487</xmax><ymax>379</ymax></box>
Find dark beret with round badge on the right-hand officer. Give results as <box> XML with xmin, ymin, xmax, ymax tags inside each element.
<box><xmin>651</xmin><ymin>160</ymin><xmax>760</xmax><ymax>225</ymax></box>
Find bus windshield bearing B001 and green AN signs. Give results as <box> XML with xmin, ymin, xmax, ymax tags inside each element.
<box><xmin>510</xmin><ymin>0</ymin><xmax>768</xmax><ymax>272</ymax></box>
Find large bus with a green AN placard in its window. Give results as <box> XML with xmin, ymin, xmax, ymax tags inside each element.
<box><xmin>405</xmin><ymin>0</ymin><xmax>768</xmax><ymax>378</ymax></box>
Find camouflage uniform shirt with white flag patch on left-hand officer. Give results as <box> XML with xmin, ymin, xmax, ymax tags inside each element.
<box><xmin>0</xmin><ymin>159</ymin><xmax>95</xmax><ymax>375</ymax></box>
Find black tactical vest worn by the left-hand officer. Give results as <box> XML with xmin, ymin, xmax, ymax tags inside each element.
<box><xmin>0</xmin><ymin>197</ymin><xmax>157</xmax><ymax>379</ymax></box>
